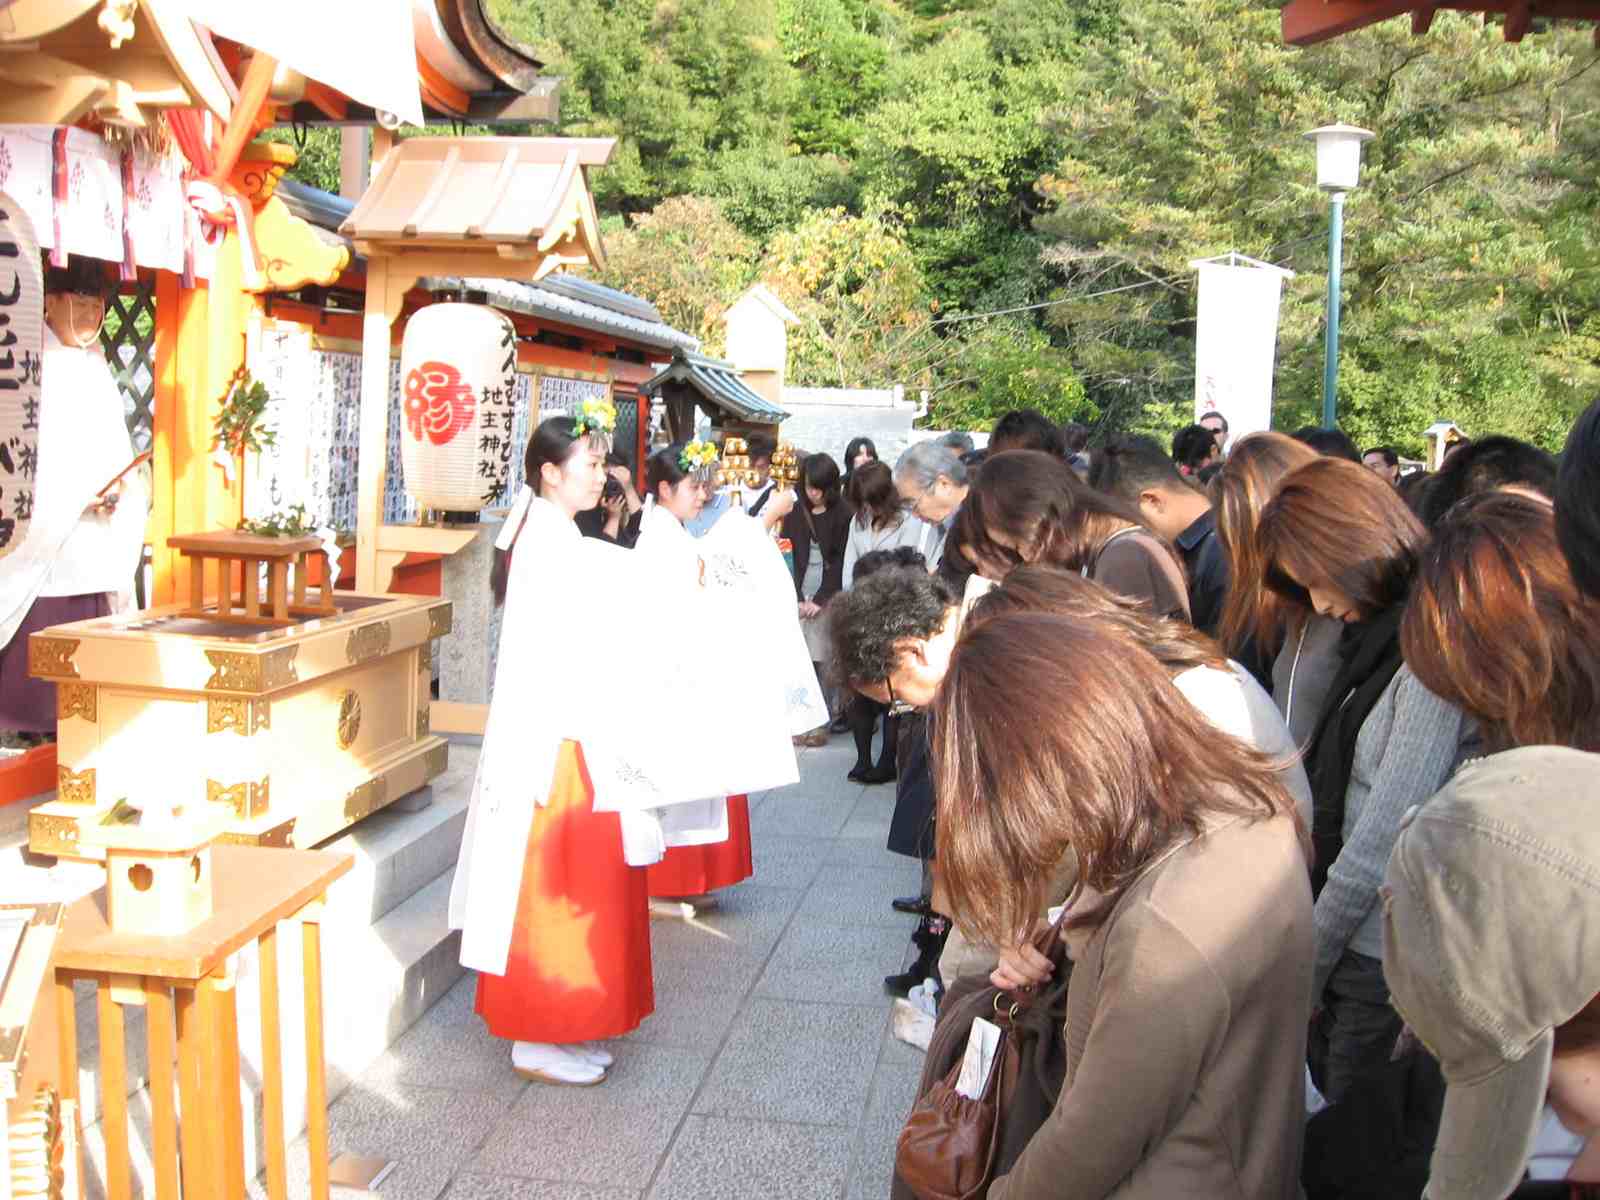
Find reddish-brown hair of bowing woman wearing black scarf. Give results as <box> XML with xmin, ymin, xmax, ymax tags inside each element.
<box><xmin>1256</xmin><ymin>458</ymin><xmax>1427</xmax><ymax>616</ymax></box>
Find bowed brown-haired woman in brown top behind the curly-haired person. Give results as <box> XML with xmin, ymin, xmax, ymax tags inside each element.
<box><xmin>950</xmin><ymin>450</ymin><xmax>1189</xmax><ymax>621</ymax></box>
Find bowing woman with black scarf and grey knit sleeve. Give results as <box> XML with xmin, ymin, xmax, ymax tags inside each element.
<box><xmin>1256</xmin><ymin>458</ymin><xmax>1474</xmax><ymax>1102</ymax></box>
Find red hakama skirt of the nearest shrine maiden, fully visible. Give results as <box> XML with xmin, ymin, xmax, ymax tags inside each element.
<box><xmin>477</xmin><ymin>741</ymin><xmax>656</xmax><ymax>1045</ymax></box>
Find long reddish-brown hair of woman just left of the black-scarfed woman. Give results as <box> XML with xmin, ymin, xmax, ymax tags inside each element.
<box><xmin>1211</xmin><ymin>434</ymin><xmax>1317</xmax><ymax>654</ymax></box>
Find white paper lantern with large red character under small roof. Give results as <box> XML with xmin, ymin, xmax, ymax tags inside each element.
<box><xmin>400</xmin><ymin>304</ymin><xmax>517</xmax><ymax>512</ymax></box>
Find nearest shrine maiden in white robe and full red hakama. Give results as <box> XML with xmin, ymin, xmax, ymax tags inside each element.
<box><xmin>450</xmin><ymin>405</ymin><xmax>654</xmax><ymax>1085</ymax></box>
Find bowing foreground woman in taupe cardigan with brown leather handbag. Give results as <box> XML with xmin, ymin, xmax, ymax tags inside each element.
<box><xmin>930</xmin><ymin>613</ymin><xmax>1310</xmax><ymax>1200</ymax></box>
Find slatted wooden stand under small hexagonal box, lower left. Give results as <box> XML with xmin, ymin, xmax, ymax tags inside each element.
<box><xmin>54</xmin><ymin>845</ymin><xmax>354</xmax><ymax>1200</ymax></box>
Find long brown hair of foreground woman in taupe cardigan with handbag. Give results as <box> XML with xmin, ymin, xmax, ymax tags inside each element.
<box><xmin>928</xmin><ymin>620</ymin><xmax>1298</xmax><ymax>946</ymax></box>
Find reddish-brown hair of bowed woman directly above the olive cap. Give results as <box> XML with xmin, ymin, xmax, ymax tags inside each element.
<box><xmin>1400</xmin><ymin>491</ymin><xmax>1600</xmax><ymax>750</ymax></box>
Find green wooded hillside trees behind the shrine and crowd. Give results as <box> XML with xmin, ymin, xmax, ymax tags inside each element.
<box><xmin>272</xmin><ymin>0</ymin><xmax>1600</xmax><ymax>451</ymax></box>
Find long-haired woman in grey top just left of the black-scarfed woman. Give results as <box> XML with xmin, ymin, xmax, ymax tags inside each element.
<box><xmin>1211</xmin><ymin>434</ymin><xmax>1344</xmax><ymax>746</ymax></box>
